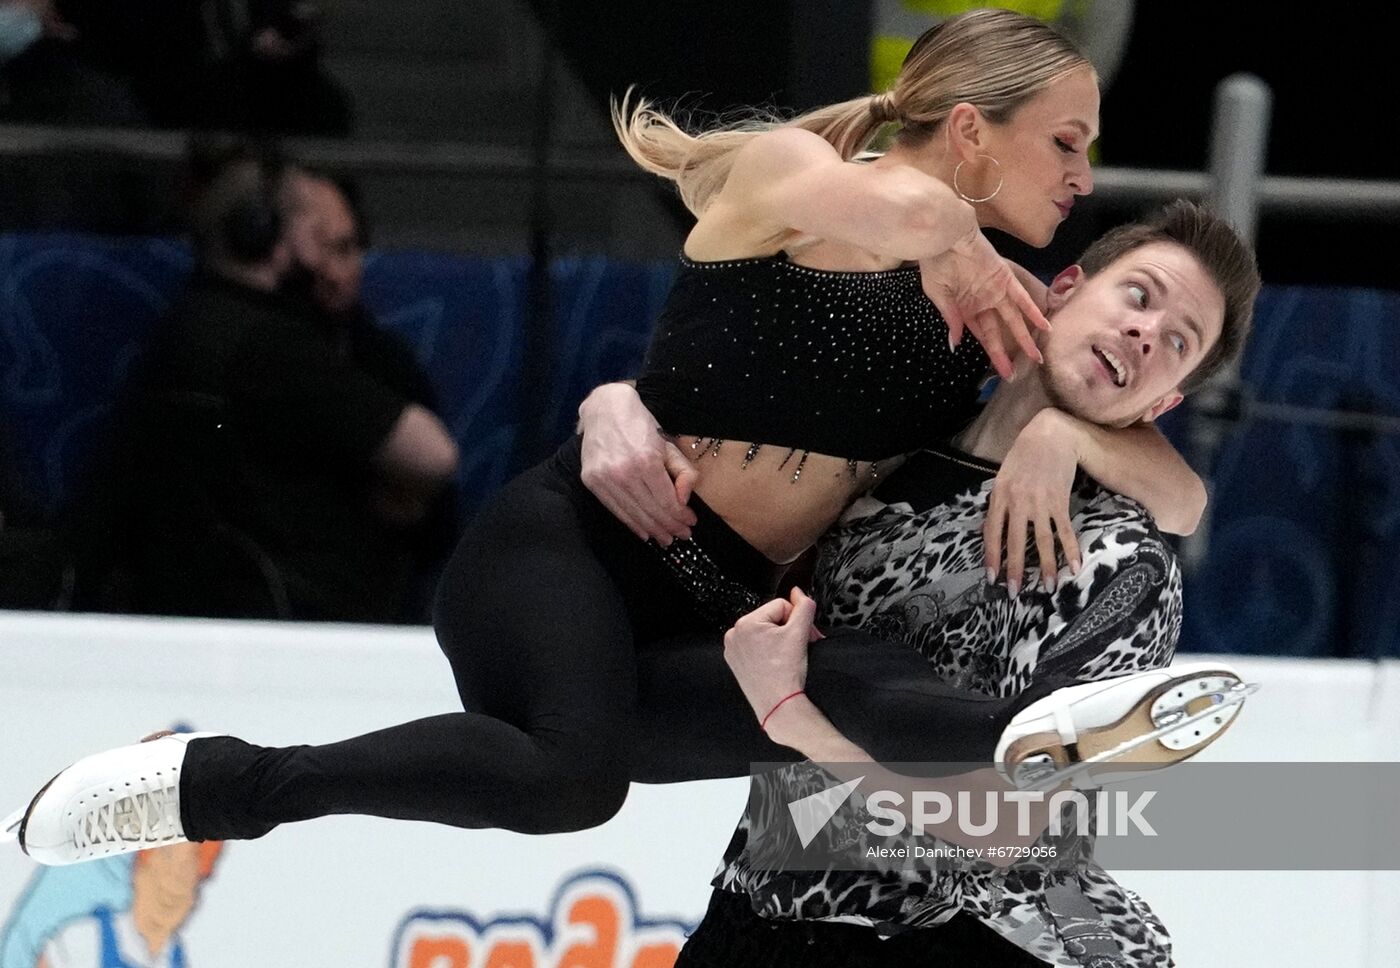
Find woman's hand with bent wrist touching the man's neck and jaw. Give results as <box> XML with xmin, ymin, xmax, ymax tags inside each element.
<box><xmin>918</xmin><ymin>231</ymin><xmax>1050</xmax><ymax>380</ymax></box>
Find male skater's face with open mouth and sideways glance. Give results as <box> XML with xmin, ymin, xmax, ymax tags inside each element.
<box><xmin>1040</xmin><ymin>242</ymin><xmax>1225</xmax><ymax>427</ymax></box>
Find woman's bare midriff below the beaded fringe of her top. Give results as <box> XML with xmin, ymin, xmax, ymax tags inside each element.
<box><xmin>675</xmin><ymin>436</ymin><xmax>896</xmax><ymax>563</ymax></box>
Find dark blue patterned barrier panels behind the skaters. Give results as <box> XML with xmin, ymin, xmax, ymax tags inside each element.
<box><xmin>0</xmin><ymin>234</ymin><xmax>1400</xmax><ymax>656</ymax></box>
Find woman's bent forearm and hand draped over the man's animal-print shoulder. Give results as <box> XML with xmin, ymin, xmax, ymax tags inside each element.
<box><xmin>983</xmin><ymin>408</ymin><xmax>1205</xmax><ymax>594</ymax></box>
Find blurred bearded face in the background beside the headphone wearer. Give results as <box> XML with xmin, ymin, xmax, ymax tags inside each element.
<box><xmin>288</xmin><ymin>175</ymin><xmax>364</xmax><ymax>312</ymax></box>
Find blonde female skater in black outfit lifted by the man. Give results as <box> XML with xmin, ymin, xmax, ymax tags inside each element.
<box><xmin>15</xmin><ymin>11</ymin><xmax>1194</xmax><ymax>863</ymax></box>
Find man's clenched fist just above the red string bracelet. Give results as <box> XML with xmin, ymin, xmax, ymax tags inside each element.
<box><xmin>724</xmin><ymin>588</ymin><xmax>816</xmax><ymax>723</ymax></box>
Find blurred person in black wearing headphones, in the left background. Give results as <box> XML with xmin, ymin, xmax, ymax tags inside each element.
<box><xmin>80</xmin><ymin>142</ymin><xmax>456</xmax><ymax>622</ymax></box>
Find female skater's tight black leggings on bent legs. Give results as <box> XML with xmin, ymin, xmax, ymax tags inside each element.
<box><xmin>181</xmin><ymin>441</ymin><xmax>1033</xmax><ymax>839</ymax></box>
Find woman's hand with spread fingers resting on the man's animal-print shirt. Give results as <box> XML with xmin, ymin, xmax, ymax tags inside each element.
<box><xmin>981</xmin><ymin>409</ymin><xmax>1079</xmax><ymax>595</ymax></box>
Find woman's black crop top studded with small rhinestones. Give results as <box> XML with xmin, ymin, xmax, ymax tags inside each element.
<box><xmin>637</xmin><ymin>255</ymin><xmax>990</xmax><ymax>473</ymax></box>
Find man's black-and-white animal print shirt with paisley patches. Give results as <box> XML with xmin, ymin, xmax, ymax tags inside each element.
<box><xmin>714</xmin><ymin>448</ymin><xmax>1182</xmax><ymax>968</ymax></box>
